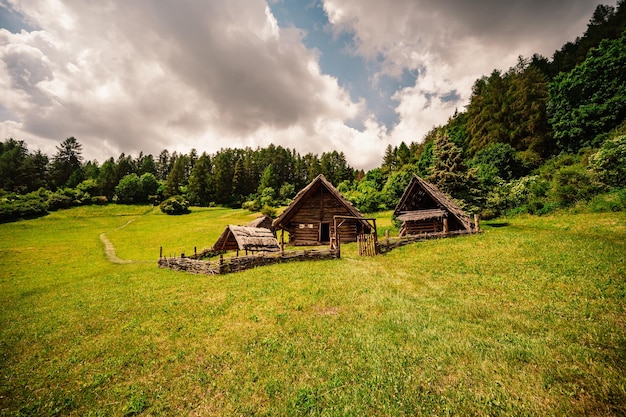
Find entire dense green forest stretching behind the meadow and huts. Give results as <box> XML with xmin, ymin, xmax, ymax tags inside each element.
<box><xmin>0</xmin><ymin>0</ymin><xmax>626</xmax><ymax>221</ymax></box>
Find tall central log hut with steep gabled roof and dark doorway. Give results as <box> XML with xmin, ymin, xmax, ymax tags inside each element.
<box><xmin>272</xmin><ymin>174</ymin><xmax>371</xmax><ymax>246</ymax></box>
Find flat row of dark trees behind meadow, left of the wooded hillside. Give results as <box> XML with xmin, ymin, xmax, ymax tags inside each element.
<box><xmin>0</xmin><ymin>137</ymin><xmax>358</xmax><ymax>217</ymax></box>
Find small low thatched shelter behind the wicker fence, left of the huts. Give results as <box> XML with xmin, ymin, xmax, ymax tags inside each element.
<box><xmin>213</xmin><ymin>224</ymin><xmax>280</xmax><ymax>255</ymax></box>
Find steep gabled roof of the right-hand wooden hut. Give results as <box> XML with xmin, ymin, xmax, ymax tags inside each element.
<box><xmin>393</xmin><ymin>175</ymin><xmax>472</xmax><ymax>230</ymax></box>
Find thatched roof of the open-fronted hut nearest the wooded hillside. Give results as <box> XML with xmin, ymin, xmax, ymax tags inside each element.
<box><xmin>394</xmin><ymin>175</ymin><xmax>472</xmax><ymax>230</ymax></box>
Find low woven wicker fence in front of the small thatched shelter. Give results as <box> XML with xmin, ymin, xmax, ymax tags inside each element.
<box><xmin>159</xmin><ymin>250</ymin><xmax>337</xmax><ymax>275</ymax></box>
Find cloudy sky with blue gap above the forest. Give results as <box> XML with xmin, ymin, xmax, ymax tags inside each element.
<box><xmin>0</xmin><ymin>0</ymin><xmax>616</xmax><ymax>169</ymax></box>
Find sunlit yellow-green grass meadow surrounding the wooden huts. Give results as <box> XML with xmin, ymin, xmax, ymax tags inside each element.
<box><xmin>0</xmin><ymin>205</ymin><xmax>626</xmax><ymax>416</ymax></box>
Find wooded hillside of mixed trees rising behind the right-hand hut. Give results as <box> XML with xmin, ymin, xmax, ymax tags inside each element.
<box><xmin>341</xmin><ymin>0</ymin><xmax>626</xmax><ymax>217</ymax></box>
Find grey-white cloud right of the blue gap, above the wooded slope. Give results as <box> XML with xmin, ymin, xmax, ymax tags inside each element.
<box><xmin>324</xmin><ymin>0</ymin><xmax>595</xmax><ymax>144</ymax></box>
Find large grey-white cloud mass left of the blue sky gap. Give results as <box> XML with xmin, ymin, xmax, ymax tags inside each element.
<box><xmin>0</xmin><ymin>0</ymin><xmax>376</xmax><ymax>166</ymax></box>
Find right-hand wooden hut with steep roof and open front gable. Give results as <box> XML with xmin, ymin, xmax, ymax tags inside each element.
<box><xmin>393</xmin><ymin>175</ymin><xmax>474</xmax><ymax>236</ymax></box>
